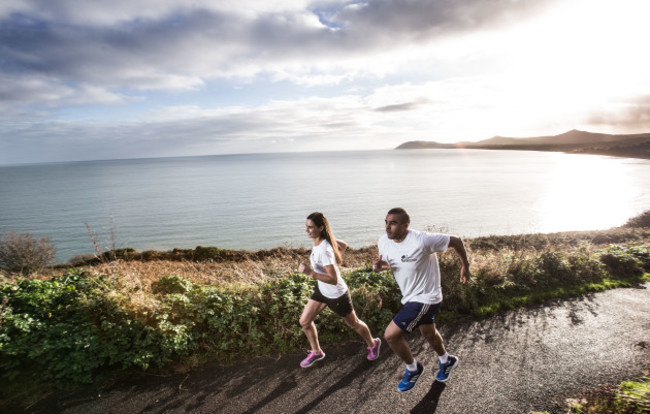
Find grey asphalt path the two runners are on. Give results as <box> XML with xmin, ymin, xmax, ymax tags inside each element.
<box><xmin>17</xmin><ymin>284</ymin><xmax>650</xmax><ymax>414</ymax></box>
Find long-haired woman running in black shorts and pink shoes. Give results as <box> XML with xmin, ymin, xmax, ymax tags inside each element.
<box><xmin>298</xmin><ymin>212</ymin><xmax>381</xmax><ymax>368</ymax></box>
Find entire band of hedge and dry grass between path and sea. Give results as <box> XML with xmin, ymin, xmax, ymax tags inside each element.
<box><xmin>0</xmin><ymin>212</ymin><xmax>650</xmax><ymax>408</ymax></box>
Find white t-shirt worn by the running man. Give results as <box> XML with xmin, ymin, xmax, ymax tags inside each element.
<box><xmin>377</xmin><ymin>230</ymin><xmax>449</xmax><ymax>305</ymax></box>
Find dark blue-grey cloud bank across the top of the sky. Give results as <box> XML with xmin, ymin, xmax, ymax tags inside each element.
<box><xmin>0</xmin><ymin>0</ymin><xmax>549</xmax><ymax>103</ymax></box>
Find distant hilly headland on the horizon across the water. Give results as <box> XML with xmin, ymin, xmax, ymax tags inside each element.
<box><xmin>395</xmin><ymin>129</ymin><xmax>650</xmax><ymax>159</ymax></box>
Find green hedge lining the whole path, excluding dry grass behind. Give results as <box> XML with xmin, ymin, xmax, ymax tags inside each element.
<box><xmin>0</xmin><ymin>246</ymin><xmax>650</xmax><ymax>383</ymax></box>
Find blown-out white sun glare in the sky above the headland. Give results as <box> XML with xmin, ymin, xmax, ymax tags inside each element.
<box><xmin>430</xmin><ymin>0</ymin><xmax>650</xmax><ymax>136</ymax></box>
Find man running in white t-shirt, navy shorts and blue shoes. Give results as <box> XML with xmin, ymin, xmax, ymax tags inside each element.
<box><xmin>373</xmin><ymin>208</ymin><xmax>470</xmax><ymax>392</ymax></box>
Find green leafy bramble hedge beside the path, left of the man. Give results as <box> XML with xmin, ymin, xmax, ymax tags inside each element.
<box><xmin>0</xmin><ymin>270</ymin><xmax>397</xmax><ymax>383</ymax></box>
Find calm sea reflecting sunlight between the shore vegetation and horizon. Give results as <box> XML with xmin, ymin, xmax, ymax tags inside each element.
<box><xmin>0</xmin><ymin>150</ymin><xmax>650</xmax><ymax>262</ymax></box>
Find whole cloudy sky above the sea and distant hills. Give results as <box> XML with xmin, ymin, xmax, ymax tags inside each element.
<box><xmin>0</xmin><ymin>0</ymin><xmax>650</xmax><ymax>164</ymax></box>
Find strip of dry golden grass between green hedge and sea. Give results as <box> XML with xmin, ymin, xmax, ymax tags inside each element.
<box><xmin>0</xmin><ymin>228</ymin><xmax>650</xmax><ymax>295</ymax></box>
